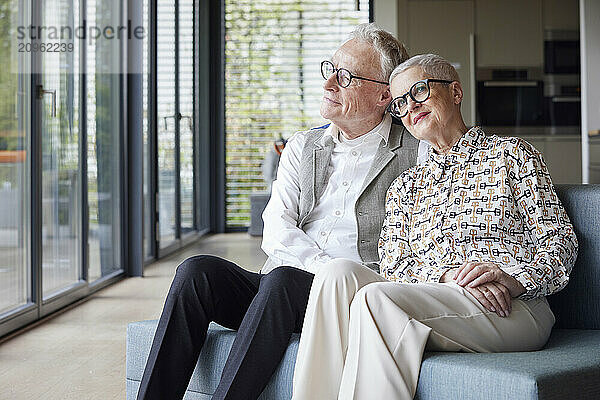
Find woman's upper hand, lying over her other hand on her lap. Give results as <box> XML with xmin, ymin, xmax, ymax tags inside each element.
<box><xmin>454</xmin><ymin>262</ymin><xmax>525</xmax><ymax>297</ymax></box>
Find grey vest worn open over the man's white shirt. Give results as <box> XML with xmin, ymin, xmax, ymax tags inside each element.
<box><xmin>267</xmin><ymin>124</ymin><xmax>419</xmax><ymax>271</ymax></box>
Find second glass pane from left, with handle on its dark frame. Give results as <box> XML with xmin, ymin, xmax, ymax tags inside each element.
<box><xmin>38</xmin><ymin>0</ymin><xmax>83</xmax><ymax>300</ymax></box>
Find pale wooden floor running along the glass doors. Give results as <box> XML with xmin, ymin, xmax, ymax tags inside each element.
<box><xmin>0</xmin><ymin>233</ymin><xmax>265</xmax><ymax>400</ymax></box>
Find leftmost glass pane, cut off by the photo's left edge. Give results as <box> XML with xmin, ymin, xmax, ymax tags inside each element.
<box><xmin>0</xmin><ymin>0</ymin><xmax>32</xmax><ymax>321</ymax></box>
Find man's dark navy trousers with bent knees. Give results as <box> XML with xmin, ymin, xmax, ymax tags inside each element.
<box><xmin>138</xmin><ymin>255</ymin><xmax>314</xmax><ymax>400</ymax></box>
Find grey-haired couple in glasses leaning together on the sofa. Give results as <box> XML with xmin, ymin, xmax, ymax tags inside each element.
<box><xmin>138</xmin><ymin>24</ymin><xmax>577</xmax><ymax>400</ymax></box>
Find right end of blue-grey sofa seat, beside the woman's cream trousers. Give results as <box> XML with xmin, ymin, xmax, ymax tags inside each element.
<box><xmin>415</xmin><ymin>329</ymin><xmax>600</xmax><ymax>400</ymax></box>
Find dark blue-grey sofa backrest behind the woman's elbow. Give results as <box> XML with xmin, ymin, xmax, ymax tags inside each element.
<box><xmin>548</xmin><ymin>185</ymin><xmax>600</xmax><ymax>329</ymax></box>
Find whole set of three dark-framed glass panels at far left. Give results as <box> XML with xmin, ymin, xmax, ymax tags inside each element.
<box><xmin>0</xmin><ymin>0</ymin><xmax>126</xmax><ymax>336</ymax></box>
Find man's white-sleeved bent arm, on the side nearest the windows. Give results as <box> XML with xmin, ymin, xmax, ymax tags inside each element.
<box><xmin>262</xmin><ymin>133</ymin><xmax>331</xmax><ymax>273</ymax></box>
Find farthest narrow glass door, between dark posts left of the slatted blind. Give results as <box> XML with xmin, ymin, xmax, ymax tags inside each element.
<box><xmin>156</xmin><ymin>0</ymin><xmax>196</xmax><ymax>253</ymax></box>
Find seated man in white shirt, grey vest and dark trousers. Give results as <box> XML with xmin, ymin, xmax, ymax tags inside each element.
<box><xmin>138</xmin><ymin>24</ymin><xmax>426</xmax><ymax>400</ymax></box>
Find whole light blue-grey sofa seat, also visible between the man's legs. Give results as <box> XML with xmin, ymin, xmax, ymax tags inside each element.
<box><xmin>126</xmin><ymin>321</ymin><xmax>600</xmax><ymax>400</ymax></box>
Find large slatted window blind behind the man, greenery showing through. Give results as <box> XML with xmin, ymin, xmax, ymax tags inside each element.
<box><xmin>225</xmin><ymin>0</ymin><xmax>369</xmax><ymax>228</ymax></box>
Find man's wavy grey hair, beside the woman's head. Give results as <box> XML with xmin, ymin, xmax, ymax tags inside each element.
<box><xmin>350</xmin><ymin>23</ymin><xmax>408</xmax><ymax>81</ymax></box>
